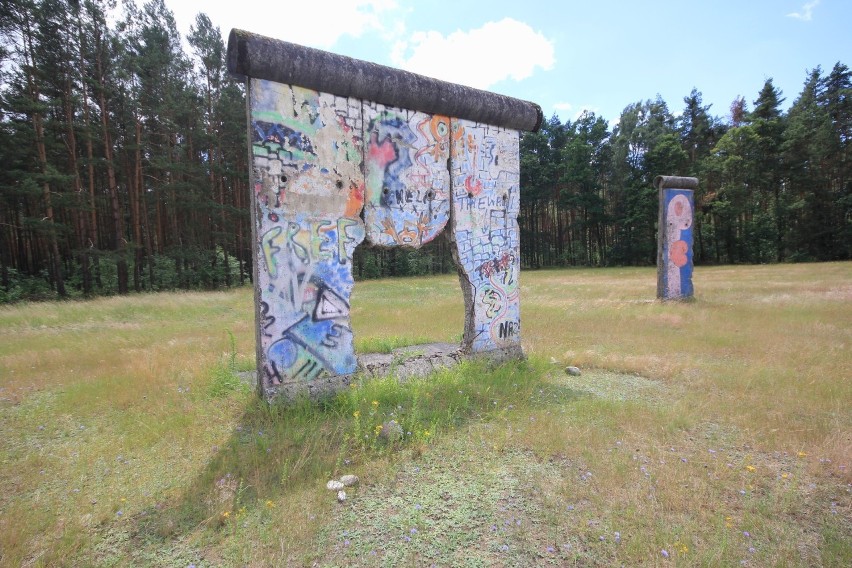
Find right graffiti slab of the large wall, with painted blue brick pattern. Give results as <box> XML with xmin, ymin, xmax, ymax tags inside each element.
<box><xmin>450</xmin><ymin>119</ymin><xmax>521</xmax><ymax>354</ymax></box>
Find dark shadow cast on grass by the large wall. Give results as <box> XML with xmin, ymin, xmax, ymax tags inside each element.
<box><xmin>123</xmin><ymin>360</ymin><xmax>583</xmax><ymax>547</ymax></box>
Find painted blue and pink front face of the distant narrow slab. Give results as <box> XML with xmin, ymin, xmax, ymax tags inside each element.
<box><xmin>662</xmin><ymin>189</ymin><xmax>693</xmax><ymax>298</ymax></box>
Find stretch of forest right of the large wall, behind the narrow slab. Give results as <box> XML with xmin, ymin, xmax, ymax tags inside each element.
<box><xmin>520</xmin><ymin>74</ymin><xmax>852</xmax><ymax>267</ymax></box>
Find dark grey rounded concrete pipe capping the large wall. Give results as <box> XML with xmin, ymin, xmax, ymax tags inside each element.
<box><xmin>228</xmin><ymin>29</ymin><xmax>544</xmax><ymax>132</ymax></box>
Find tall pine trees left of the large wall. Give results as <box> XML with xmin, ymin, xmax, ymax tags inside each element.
<box><xmin>0</xmin><ymin>0</ymin><xmax>251</xmax><ymax>301</ymax></box>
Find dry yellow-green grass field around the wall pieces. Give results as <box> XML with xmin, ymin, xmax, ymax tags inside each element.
<box><xmin>0</xmin><ymin>263</ymin><xmax>852</xmax><ymax>567</ymax></box>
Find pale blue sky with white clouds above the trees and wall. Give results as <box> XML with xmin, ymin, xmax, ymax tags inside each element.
<box><xmin>161</xmin><ymin>0</ymin><xmax>852</xmax><ymax>124</ymax></box>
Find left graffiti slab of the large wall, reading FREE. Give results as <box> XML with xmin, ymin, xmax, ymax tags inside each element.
<box><xmin>250</xmin><ymin>80</ymin><xmax>365</xmax><ymax>386</ymax></box>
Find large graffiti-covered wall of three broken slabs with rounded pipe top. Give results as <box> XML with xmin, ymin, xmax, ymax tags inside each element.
<box><xmin>228</xmin><ymin>30</ymin><xmax>543</xmax><ymax>397</ymax></box>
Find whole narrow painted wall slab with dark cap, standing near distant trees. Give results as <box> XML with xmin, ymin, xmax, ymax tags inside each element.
<box><xmin>655</xmin><ymin>176</ymin><xmax>698</xmax><ymax>300</ymax></box>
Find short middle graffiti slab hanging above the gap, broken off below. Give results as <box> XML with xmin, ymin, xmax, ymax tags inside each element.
<box><xmin>364</xmin><ymin>102</ymin><xmax>449</xmax><ymax>248</ymax></box>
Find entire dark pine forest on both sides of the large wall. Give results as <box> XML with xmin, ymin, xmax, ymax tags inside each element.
<box><xmin>0</xmin><ymin>0</ymin><xmax>852</xmax><ymax>303</ymax></box>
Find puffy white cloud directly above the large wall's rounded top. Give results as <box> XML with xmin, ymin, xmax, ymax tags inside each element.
<box><xmin>391</xmin><ymin>18</ymin><xmax>555</xmax><ymax>89</ymax></box>
